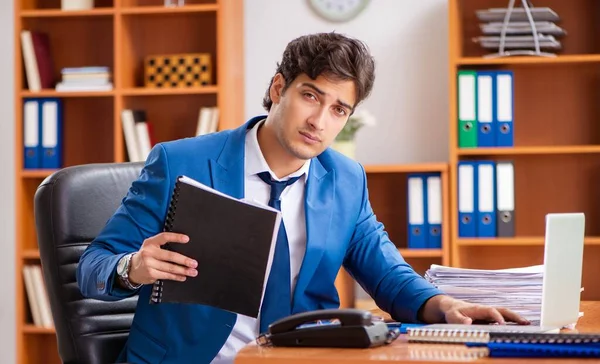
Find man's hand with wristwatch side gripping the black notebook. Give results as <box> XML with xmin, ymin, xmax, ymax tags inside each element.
<box><xmin>129</xmin><ymin>232</ymin><xmax>198</xmax><ymax>284</ymax></box>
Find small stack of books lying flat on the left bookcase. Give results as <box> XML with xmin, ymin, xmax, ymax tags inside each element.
<box><xmin>56</xmin><ymin>67</ymin><xmax>113</xmax><ymax>92</ymax></box>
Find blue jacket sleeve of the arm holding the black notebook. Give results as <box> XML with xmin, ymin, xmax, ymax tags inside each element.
<box><xmin>76</xmin><ymin>144</ymin><xmax>172</xmax><ymax>301</ymax></box>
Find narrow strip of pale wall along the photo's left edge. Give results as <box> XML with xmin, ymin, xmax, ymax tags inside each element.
<box><xmin>0</xmin><ymin>0</ymin><xmax>16</xmax><ymax>363</ymax></box>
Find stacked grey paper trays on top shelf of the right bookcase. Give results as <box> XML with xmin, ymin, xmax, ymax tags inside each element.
<box><xmin>473</xmin><ymin>7</ymin><xmax>566</xmax><ymax>52</ymax></box>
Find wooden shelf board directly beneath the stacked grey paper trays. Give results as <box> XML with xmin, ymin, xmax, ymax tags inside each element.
<box><xmin>456</xmin><ymin>54</ymin><xmax>600</xmax><ymax>66</ymax></box>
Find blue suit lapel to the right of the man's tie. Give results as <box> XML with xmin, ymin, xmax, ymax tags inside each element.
<box><xmin>292</xmin><ymin>158</ymin><xmax>335</xmax><ymax>313</ymax></box>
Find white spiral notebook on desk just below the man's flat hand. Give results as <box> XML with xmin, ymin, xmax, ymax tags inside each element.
<box><xmin>406</xmin><ymin>324</ymin><xmax>560</xmax><ymax>344</ymax></box>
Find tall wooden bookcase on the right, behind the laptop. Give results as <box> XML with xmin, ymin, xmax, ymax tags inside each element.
<box><xmin>448</xmin><ymin>0</ymin><xmax>600</xmax><ymax>300</ymax></box>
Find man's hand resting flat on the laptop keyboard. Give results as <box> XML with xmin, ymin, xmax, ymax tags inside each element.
<box><xmin>421</xmin><ymin>295</ymin><xmax>529</xmax><ymax>325</ymax></box>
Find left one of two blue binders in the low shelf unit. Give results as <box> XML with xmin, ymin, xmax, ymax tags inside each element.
<box><xmin>407</xmin><ymin>174</ymin><xmax>427</xmax><ymax>249</ymax></box>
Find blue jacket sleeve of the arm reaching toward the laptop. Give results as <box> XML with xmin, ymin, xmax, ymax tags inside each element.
<box><xmin>344</xmin><ymin>166</ymin><xmax>443</xmax><ymax>322</ymax></box>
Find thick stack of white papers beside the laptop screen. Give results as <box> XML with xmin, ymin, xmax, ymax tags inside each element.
<box><xmin>425</xmin><ymin>264</ymin><xmax>544</xmax><ymax>322</ymax></box>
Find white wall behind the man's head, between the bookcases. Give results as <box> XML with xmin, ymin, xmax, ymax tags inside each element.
<box><xmin>244</xmin><ymin>0</ymin><xmax>448</xmax><ymax>164</ymax></box>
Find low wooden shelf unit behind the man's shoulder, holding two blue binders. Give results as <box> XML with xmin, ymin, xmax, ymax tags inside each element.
<box><xmin>336</xmin><ymin>163</ymin><xmax>450</xmax><ymax>309</ymax></box>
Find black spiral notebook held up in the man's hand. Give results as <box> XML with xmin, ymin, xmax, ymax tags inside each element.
<box><xmin>150</xmin><ymin>176</ymin><xmax>281</xmax><ymax>318</ymax></box>
